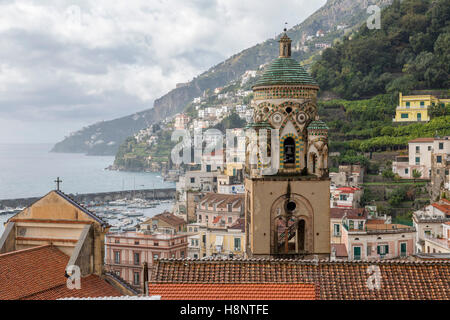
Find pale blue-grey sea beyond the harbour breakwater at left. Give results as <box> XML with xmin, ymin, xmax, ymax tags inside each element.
<box><xmin>0</xmin><ymin>144</ymin><xmax>175</xmax><ymax>199</ymax></box>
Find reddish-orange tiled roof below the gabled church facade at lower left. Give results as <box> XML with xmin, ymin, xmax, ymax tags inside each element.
<box><xmin>0</xmin><ymin>245</ymin><xmax>121</xmax><ymax>300</ymax></box>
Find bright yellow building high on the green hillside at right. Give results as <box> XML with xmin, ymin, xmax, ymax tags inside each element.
<box><xmin>394</xmin><ymin>92</ymin><xmax>450</xmax><ymax>122</ymax></box>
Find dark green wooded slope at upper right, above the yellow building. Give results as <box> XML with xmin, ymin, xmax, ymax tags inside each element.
<box><xmin>312</xmin><ymin>0</ymin><xmax>450</xmax><ymax>99</ymax></box>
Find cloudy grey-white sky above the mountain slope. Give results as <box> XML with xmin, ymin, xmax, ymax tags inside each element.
<box><xmin>0</xmin><ymin>0</ymin><xmax>326</xmax><ymax>143</ymax></box>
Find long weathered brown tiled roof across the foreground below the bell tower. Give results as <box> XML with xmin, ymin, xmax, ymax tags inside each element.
<box><xmin>151</xmin><ymin>259</ymin><xmax>450</xmax><ymax>300</ymax></box>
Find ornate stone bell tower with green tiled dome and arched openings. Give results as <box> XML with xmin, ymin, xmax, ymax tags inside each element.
<box><xmin>245</xmin><ymin>29</ymin><xmax>330</xmax><ymax>258</ymax></box>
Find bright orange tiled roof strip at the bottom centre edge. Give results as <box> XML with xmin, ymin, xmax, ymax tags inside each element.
<box><xmin>149</xmin><ymin>283</ymin><xmax>319</xmax><ymax>300</ymax></box>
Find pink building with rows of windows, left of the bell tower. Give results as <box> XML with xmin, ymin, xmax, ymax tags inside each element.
<box><xmin>105</xmin><ymin>231</ymin><xmax>187</xmax><ymax>288</ymax></box>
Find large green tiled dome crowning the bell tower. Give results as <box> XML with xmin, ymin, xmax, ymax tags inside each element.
<box><xmin>253</xmin><ymin>58</ymin><xmax>318</xmax><ymax>87</ymax></box>
